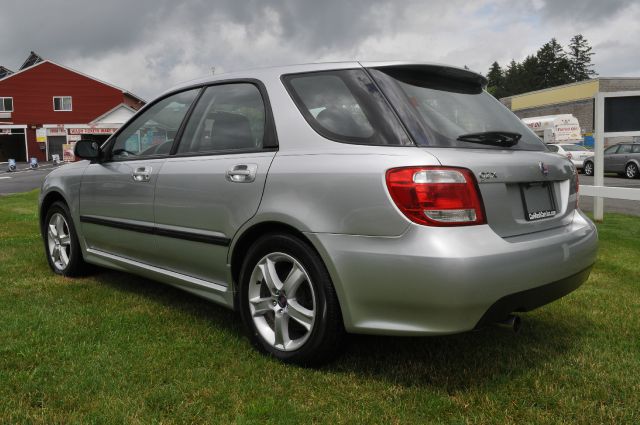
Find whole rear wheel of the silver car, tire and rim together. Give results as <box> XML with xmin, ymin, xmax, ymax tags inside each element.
<box><xmin>239</xmin><ymin>234</ymin><xmax>344</xmax><ymax>365</ymax></box>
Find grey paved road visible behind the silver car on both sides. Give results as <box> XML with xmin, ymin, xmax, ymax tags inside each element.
<box><xmin>0</xmin><ymin>163</ymin><xmax>640</xmax><ymax>216</ymax></box>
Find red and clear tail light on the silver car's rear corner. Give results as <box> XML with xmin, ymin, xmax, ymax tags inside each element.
<box><xmin>386</xmin><ymin>167</ymin><xmax>486</xmax><ymax>226</ymax></box>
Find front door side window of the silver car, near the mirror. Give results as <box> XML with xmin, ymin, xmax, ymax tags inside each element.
<box><xmin>111</xmin><ymin>89</ymin><xmax>200</xmax><ymax>160</ymax></box>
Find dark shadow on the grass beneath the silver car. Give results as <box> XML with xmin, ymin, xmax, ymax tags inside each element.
<box><xmin>87</xmin><ymin>271</ymin><xmax>590</xmax><ymax>392</ymax></box>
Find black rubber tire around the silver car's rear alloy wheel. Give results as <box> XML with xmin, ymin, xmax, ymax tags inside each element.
<box><xmin>237</xmin><ymin>234</ymin><xmax>345</xmax><ymax>366</ymax></box>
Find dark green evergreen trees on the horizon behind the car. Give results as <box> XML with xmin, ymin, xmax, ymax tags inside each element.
<box><xmin>487</xmin><ymin>34</ymin><xmax>597</xmax><ymax>99</ymax></box>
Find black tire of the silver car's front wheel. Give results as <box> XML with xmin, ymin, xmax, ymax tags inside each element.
<box><xmin>42</xmin><ymin>202</ymin><xmax>89</xmax><ymax>277</ymax></box>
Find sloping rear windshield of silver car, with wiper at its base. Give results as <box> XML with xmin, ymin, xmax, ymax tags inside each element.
<box><xmin>369</xmin><ymin>68</ymin><xmax>547</xmax><ymax>151</ymax></box>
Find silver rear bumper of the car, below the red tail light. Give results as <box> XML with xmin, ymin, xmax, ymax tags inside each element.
<box><xmin>308</xmin><ymin>211</ymin><xmax>598</xmax><ymax>335</ymax></box>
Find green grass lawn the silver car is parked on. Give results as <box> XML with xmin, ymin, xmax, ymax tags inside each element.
<box><xmin>0</xmin><ymin>192</ymin><xmax>640</xmax><ymax>424</ymax></box>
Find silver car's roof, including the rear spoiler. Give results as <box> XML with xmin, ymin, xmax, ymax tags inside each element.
<box><xmin>165</xmin><ymin>61</ymin><xmax>487</xmax><ymax>93</ymax></box>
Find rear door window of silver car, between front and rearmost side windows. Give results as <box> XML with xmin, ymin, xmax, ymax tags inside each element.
<box><xmin>178</xmin><ymin>83</ymin><xmax>265</xmax><ymax>153</ymax></box>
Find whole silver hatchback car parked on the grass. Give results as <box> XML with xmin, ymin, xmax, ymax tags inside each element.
<box><xmin>40</xmin><ymin>62</ymin><xmax>597</xmax><ymax>364</ymax></box>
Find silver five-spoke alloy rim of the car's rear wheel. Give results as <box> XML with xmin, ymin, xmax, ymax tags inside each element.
<box><xmin>248</xmin><ymin>252</ymin><xmax>317</xmax><ymax>351</ymax></box>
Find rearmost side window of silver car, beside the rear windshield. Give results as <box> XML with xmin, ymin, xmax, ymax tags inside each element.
<box><xmin>283</xmin><ymin>69</ymin><xmax>413</xmax><ymax>146</ymax></box>
